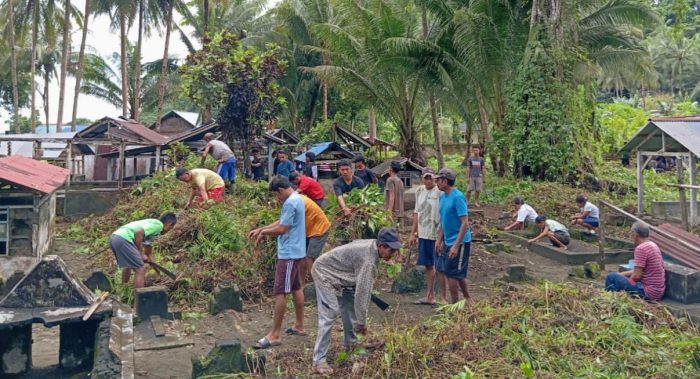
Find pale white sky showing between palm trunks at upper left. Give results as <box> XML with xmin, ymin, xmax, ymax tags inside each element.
<box><xmin>0</xmin><ymin>0</ymin><xmax>197</xmax><ymax>133</ymax></box>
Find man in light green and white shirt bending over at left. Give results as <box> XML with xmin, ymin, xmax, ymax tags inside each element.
<box><xmin>109</xmin><ymin>213</ymin><xmax>177</xmax><ymax>288</ymax></box>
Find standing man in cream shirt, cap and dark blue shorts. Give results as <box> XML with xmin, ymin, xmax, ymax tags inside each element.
<box><xmin>408</xmin><ymin>167</ymin><xmax>447</xmax><ymax>305</ymax></box>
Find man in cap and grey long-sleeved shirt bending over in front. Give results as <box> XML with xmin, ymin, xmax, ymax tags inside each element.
<box><xmin>311</xmin><ymin>228</ymin><xmax>401</xmax><ymax>375</ymax></box>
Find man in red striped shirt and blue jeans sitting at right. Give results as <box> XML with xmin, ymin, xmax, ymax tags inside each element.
<box><xmin>605</xmin><ymin>221</ymin><xmax>666</xmax><ymax>300</ymax></box>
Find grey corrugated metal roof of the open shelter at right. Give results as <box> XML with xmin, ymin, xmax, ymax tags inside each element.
<box><xmin>620</xmin><ymin>116</ymin><xmax>700</xmax><ymax>156</ymax></box>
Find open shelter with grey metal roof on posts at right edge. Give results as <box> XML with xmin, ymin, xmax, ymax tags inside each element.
<box><xmin>620</xmin><ymin>116</ymin><xmax>700</xmax><ymax>222</ymax></box>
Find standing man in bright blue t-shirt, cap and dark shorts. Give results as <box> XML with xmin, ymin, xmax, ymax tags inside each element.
<box><xmin>435</xmin><ymin>168</ymin><xmax>472</xmax><ymax>304</ymax></box>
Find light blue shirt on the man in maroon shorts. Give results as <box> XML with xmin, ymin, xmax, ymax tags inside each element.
<box><xmin>277</xmin><ymin>193</ymin><xmax>306</xmax><ymax>259</ymax></box>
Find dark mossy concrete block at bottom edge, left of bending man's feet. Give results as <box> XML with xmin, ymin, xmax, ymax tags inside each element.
<box><xmin>192</xmin><ymin>340</ymin><xmax>243</xmax><ymax>379</ymax></box>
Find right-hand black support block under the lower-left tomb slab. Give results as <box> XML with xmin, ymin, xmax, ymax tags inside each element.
<box><xmin>58</xmin><ymin>320</ymin><xmax>99</xmax><ymax>369</ymax></box>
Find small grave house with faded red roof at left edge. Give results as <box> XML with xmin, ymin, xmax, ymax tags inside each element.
<box><xmin>0</xmin><ymin>155</ymin><xmax>69</xmax><ymax>278</ymax></box>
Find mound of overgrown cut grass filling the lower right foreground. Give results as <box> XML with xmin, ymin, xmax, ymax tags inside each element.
<box><xmin>336</xmin><ymin>282</ymin><xmax>700</xmax><ymax>378</ymax></box>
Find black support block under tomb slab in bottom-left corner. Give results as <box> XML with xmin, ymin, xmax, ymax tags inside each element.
<box><xmin>0</xmin><ymin>324</ymin><xmax>32</xmax><ymax>378</ymax></box>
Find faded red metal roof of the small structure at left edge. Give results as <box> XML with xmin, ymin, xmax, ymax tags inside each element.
<box><xmin>0</xmin><ymin>155</ymin><xmax>69</xmax><ymax>193</ymax></box>
